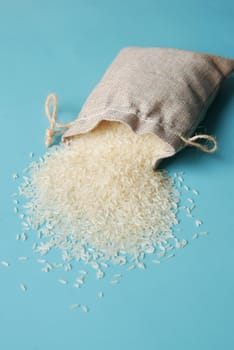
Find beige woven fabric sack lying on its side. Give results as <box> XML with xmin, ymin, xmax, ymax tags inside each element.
<box><xmin>63</xmin><ymin>47</ymin><xmax>234</xmax><ymax>157</ymax></box>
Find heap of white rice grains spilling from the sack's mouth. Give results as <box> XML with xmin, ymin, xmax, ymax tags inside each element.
<box><xmin>20</xmin><ymin>121</ymin><xmax>179</xmax><ymax>265</ymax></box>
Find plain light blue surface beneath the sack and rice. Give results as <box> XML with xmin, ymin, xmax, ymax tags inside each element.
<box><xmin>0</xmin><ymin>0</ymin><xmax>234</xmax><ymax>350</ymax></box>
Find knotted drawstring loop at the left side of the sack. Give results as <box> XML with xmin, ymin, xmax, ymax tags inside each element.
<box><xmin>45</xmin><ymin>93</ymin><xmax>73</xmax><ymax>147</ymax></box>
